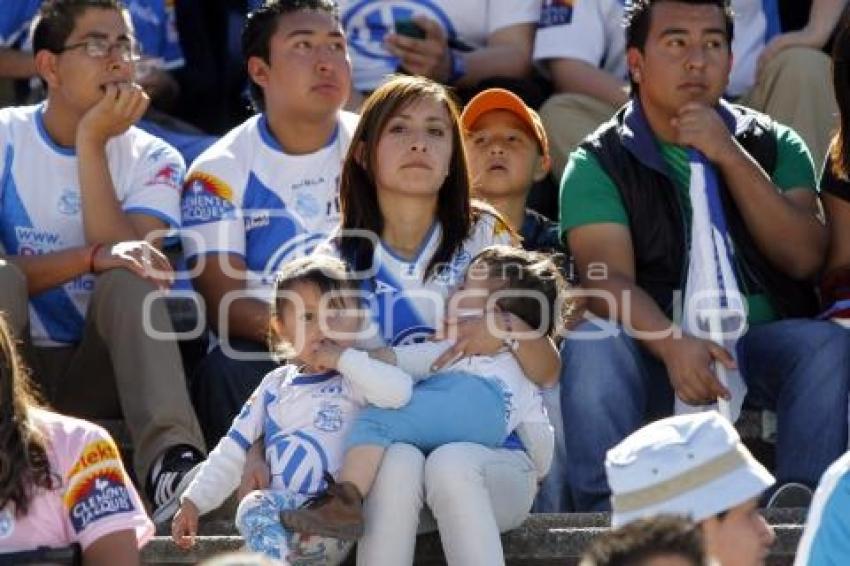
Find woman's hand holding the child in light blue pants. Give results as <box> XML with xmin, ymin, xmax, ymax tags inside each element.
<box><xmin>433</xmin><ymin>313</ymin><xmax>504</xmax><ymax>370</ymax></box>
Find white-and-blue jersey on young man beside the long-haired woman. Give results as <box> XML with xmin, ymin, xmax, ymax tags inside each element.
<box><xmin>181</xmin><ymin>112</ymin><xmax>358</xmax><ymax>301</ymax></box>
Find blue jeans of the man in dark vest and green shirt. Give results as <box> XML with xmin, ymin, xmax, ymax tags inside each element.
<box><xmin>561</xmin><ymin>319</ymin><xmax>850</xmax><ymax>511</ymax></box>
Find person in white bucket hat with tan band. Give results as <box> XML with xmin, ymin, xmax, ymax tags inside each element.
<box><xmin>605</xmin><ymin>411</ymin><xmax>776</xmax><ymax>566</ymax></box>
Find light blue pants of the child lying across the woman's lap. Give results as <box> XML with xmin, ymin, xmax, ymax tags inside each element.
<box><xmin>345</xmin><ymin>371</ymin><xmax>507</xmax><ymax>452</ymax></box>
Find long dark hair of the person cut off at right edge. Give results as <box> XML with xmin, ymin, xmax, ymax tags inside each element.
<box><xmin>829</xmin><ymin>13</ymin><xmax>850</xmax><ymax>179</ymax></box>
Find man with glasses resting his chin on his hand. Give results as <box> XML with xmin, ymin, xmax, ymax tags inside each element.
<box><xmin>0</xmin><ymin>0</ymin><xmax>203</xmax><ymax>518</ymax></box>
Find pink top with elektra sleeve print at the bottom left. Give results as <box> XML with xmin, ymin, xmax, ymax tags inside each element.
<box><xmin>0</xmin><ymin>409</ymin><xmax>154</xmax><ymax>552</ymax></box>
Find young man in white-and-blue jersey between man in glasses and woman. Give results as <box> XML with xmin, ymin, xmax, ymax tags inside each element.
<box><xmin>182</xmin><ymin>0</ymin><xmax>357</xmax><ymax>452</ymax></box>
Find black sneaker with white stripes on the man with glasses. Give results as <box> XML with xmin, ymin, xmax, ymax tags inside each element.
<box><xmin>145</xmin><ymin>444</ymin><xmax>204</xmax><ymax>524</ymax></box>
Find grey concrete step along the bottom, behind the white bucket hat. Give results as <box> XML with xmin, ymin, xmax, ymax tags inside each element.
<box><xmin>142</xmin><ymin>509</ymin><xmax>805</xmax><ymax>566</ymax></box>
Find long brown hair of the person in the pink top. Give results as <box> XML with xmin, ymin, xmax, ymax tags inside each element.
<box><xmin>0</xmin><ymin>312</ymin><xmax>59</xmax><ymax>516</ymax></box>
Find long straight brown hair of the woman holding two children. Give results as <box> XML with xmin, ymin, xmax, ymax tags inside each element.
<box><xmin>337</xmin><ymin>76</ymin><xmax>494</xmax><ymax>280</ymax></box>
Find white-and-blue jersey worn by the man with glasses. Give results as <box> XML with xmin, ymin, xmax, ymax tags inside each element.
<box><xmin>0</xmin><ymin>105</ymin><xmax>185</xmax><ymax>346</ymax></box>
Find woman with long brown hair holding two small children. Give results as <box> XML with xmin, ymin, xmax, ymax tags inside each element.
<box><xmin>334</xmin><ymin>77</ymin><xmax>560</xmax><ymax>566</ymax></box>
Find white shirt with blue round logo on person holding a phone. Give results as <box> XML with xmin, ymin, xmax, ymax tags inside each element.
<box><xmin>339</xmin><ymin>0</ymin><xmax>540</xmax><ymax>91</ymax></box>
